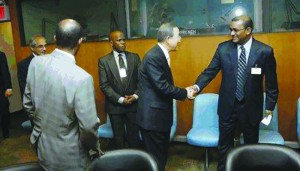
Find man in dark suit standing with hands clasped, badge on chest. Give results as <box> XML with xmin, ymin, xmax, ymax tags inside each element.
<box><xmin>98</xmin><ymin>31</ymin><xmax>141</xmax><ymax>149</ymax></box>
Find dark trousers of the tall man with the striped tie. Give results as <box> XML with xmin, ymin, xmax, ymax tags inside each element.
<box><xmin>218</xmin><ymin>99</ymin><xmax>259</xmax><ymax>171</ymax></box>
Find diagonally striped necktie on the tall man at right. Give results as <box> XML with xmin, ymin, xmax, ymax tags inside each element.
<box><xmin>235</xmin><ymin>46</ymin><xmax>246</xmax><ymax>101</ymax></box>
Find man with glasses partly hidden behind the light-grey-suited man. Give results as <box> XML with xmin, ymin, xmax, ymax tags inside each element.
<box><xmin>18</xmin><ymin>35</ymin><xmax>47</xmax><ymax>96</ymax></box>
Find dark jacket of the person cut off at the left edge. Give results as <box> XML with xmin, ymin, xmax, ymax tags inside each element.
<box><xmin>0</xmin><ymin>52</ymin><xmax>12</xmax><ymax>105</ymax></box>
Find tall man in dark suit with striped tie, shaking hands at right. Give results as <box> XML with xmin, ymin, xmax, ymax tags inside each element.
<box><xmin>194</xmin><ymin>16</ymin><xmax>278</xmax><ymax>170</ymax></box>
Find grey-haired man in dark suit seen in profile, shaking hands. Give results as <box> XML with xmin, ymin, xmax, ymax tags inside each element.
<box><xmin>137</xmin><ymin>23</ymin><xmax>192</xmax><ymax>171</ymax></box>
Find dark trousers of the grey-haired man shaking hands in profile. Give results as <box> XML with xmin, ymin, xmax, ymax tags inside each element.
<box><xmin>140</xmin><ymin>128</ymin><xmax>170</xmax><ymax>171</ymax></box>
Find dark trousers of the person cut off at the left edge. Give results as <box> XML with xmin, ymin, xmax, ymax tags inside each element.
<box><xmin>0</xmin><ymin>98</ymin><xmax>10</xmax><ymax>138</ymax></box>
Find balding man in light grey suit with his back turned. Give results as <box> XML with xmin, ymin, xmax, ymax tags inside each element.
<box><xmin>23</xmin><ymin>19</ymin><xmax>101</xmax><ymax>170</ymax></box>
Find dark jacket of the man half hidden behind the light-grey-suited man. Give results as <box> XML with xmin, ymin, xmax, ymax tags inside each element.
<box><xmin>18</xmin><ymin>54</ymin><xmax>34</xmax><ymax>96</ymax></box>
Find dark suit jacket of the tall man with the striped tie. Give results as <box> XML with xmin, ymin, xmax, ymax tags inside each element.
<box><xmin>196</xmin><ymin>39</ymin><xmax>278</xmax><ymax>124</ymax></box>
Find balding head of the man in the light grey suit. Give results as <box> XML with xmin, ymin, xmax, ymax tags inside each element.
<box><xmin>55</xmin><ymin>19</ymin><xmax>83</xmax><ymax>49</ymax></box>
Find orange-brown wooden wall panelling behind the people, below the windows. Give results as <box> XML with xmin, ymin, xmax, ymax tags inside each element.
<box><xmin>9</xmin><ymin>0</ymin><xmax>300</xmax><ymax>141</ymax></box>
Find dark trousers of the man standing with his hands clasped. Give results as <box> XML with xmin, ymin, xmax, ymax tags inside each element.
<box><xmin>109</xmin><ymin>112</ymin><xmax>140</xmax><ymax>149</ymax></box>
